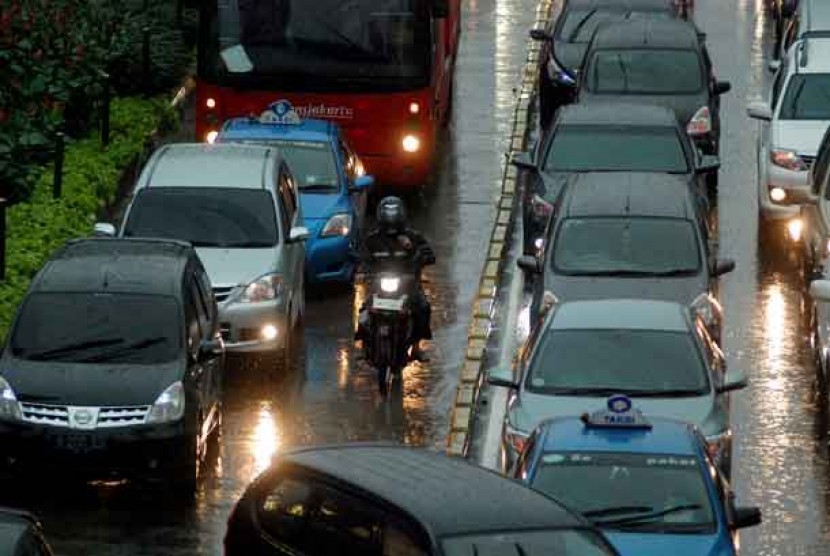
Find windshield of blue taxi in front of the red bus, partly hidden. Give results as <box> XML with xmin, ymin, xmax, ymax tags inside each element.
<box><xmin>226</xmin><ymin>139</ymin><xmax>340</xmax><ymax>193</ymax></box>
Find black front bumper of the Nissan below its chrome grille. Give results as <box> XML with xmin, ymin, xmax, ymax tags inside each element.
<box><xmin>0</xmin><ymin>420</ymin><xmax>189</xmax><ymax>479</ymax></box>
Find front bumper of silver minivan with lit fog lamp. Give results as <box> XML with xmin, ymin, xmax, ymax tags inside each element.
<box><xmin>219</xmin><ymin>296</ymin><xmax>290</xmax><ymax>353</ymax></box>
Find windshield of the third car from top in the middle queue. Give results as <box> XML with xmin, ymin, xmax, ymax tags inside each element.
<box><xmin>542</xmin><ymin>125</ymin><xmax>689</xmax><ymax>174</ymax></box>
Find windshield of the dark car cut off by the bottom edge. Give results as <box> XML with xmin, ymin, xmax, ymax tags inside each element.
<box><xmin>441</xmin><ymin>529</ymin><xmax>614</xmax><ymax>556</ymax></box>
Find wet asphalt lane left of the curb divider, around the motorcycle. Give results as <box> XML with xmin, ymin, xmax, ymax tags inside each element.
<box><xmin>0</xmin><ymin>0</ymin><xmax>536</xmax><ymax>556</ymax></box>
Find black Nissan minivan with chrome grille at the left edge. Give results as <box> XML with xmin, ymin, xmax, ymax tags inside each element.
<box><xmin>0</xmin><ymin>238</ymin><xmax>224</xmax><ymax>494</ymax></box>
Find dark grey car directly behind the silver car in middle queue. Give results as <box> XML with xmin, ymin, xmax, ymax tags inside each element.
<box><xmin>518</xmin><ymin>172</ymin><xmax>735</xmax><ymax>340</ymax></box>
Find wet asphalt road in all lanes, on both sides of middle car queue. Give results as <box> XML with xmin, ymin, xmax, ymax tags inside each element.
<box><xmin>0</xmin><ymin>0</ymin><xmax>830</xmax><ymax>556</ymax></box>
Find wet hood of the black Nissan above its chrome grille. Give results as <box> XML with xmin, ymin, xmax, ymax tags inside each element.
<box><xmin>2</xmin><ymin>356</ymin><xmax>184</xmax><ymax>407</ymax></box>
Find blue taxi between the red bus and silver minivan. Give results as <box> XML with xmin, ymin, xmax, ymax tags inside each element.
<box><xmin>216</xmin><ymin>100</ymin><xmax>375</xmax><ymax>283</ymax></box>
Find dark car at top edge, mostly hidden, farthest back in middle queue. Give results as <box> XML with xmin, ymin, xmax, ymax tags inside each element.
<box><xmin>530</xmin><ymin>0</ymin><xmax>679</xmax><ymax>127</ymax></box>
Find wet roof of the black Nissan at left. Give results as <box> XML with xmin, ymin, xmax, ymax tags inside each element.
<box><xmin>33</xmin><ymin>238</ymin><xmax>195</xmax><ymax>296</ymax></box>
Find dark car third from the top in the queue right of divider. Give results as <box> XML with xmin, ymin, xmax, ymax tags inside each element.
<box><xmin>512</xmin><ymin>102</ymin><xmax>720</xmax><ymax>255</ymax></box>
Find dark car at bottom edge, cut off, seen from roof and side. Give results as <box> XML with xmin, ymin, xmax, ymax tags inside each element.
<box><xmin>225</xmin><ymin>444</ymin><xmax>617</xmax><ymax>556</ymax></box>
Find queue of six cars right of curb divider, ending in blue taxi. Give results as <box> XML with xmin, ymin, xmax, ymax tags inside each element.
<box><xmin>488</xmin><ymin>0</ymin><xmax>761</xmax><ymax>554</ymax></box>
